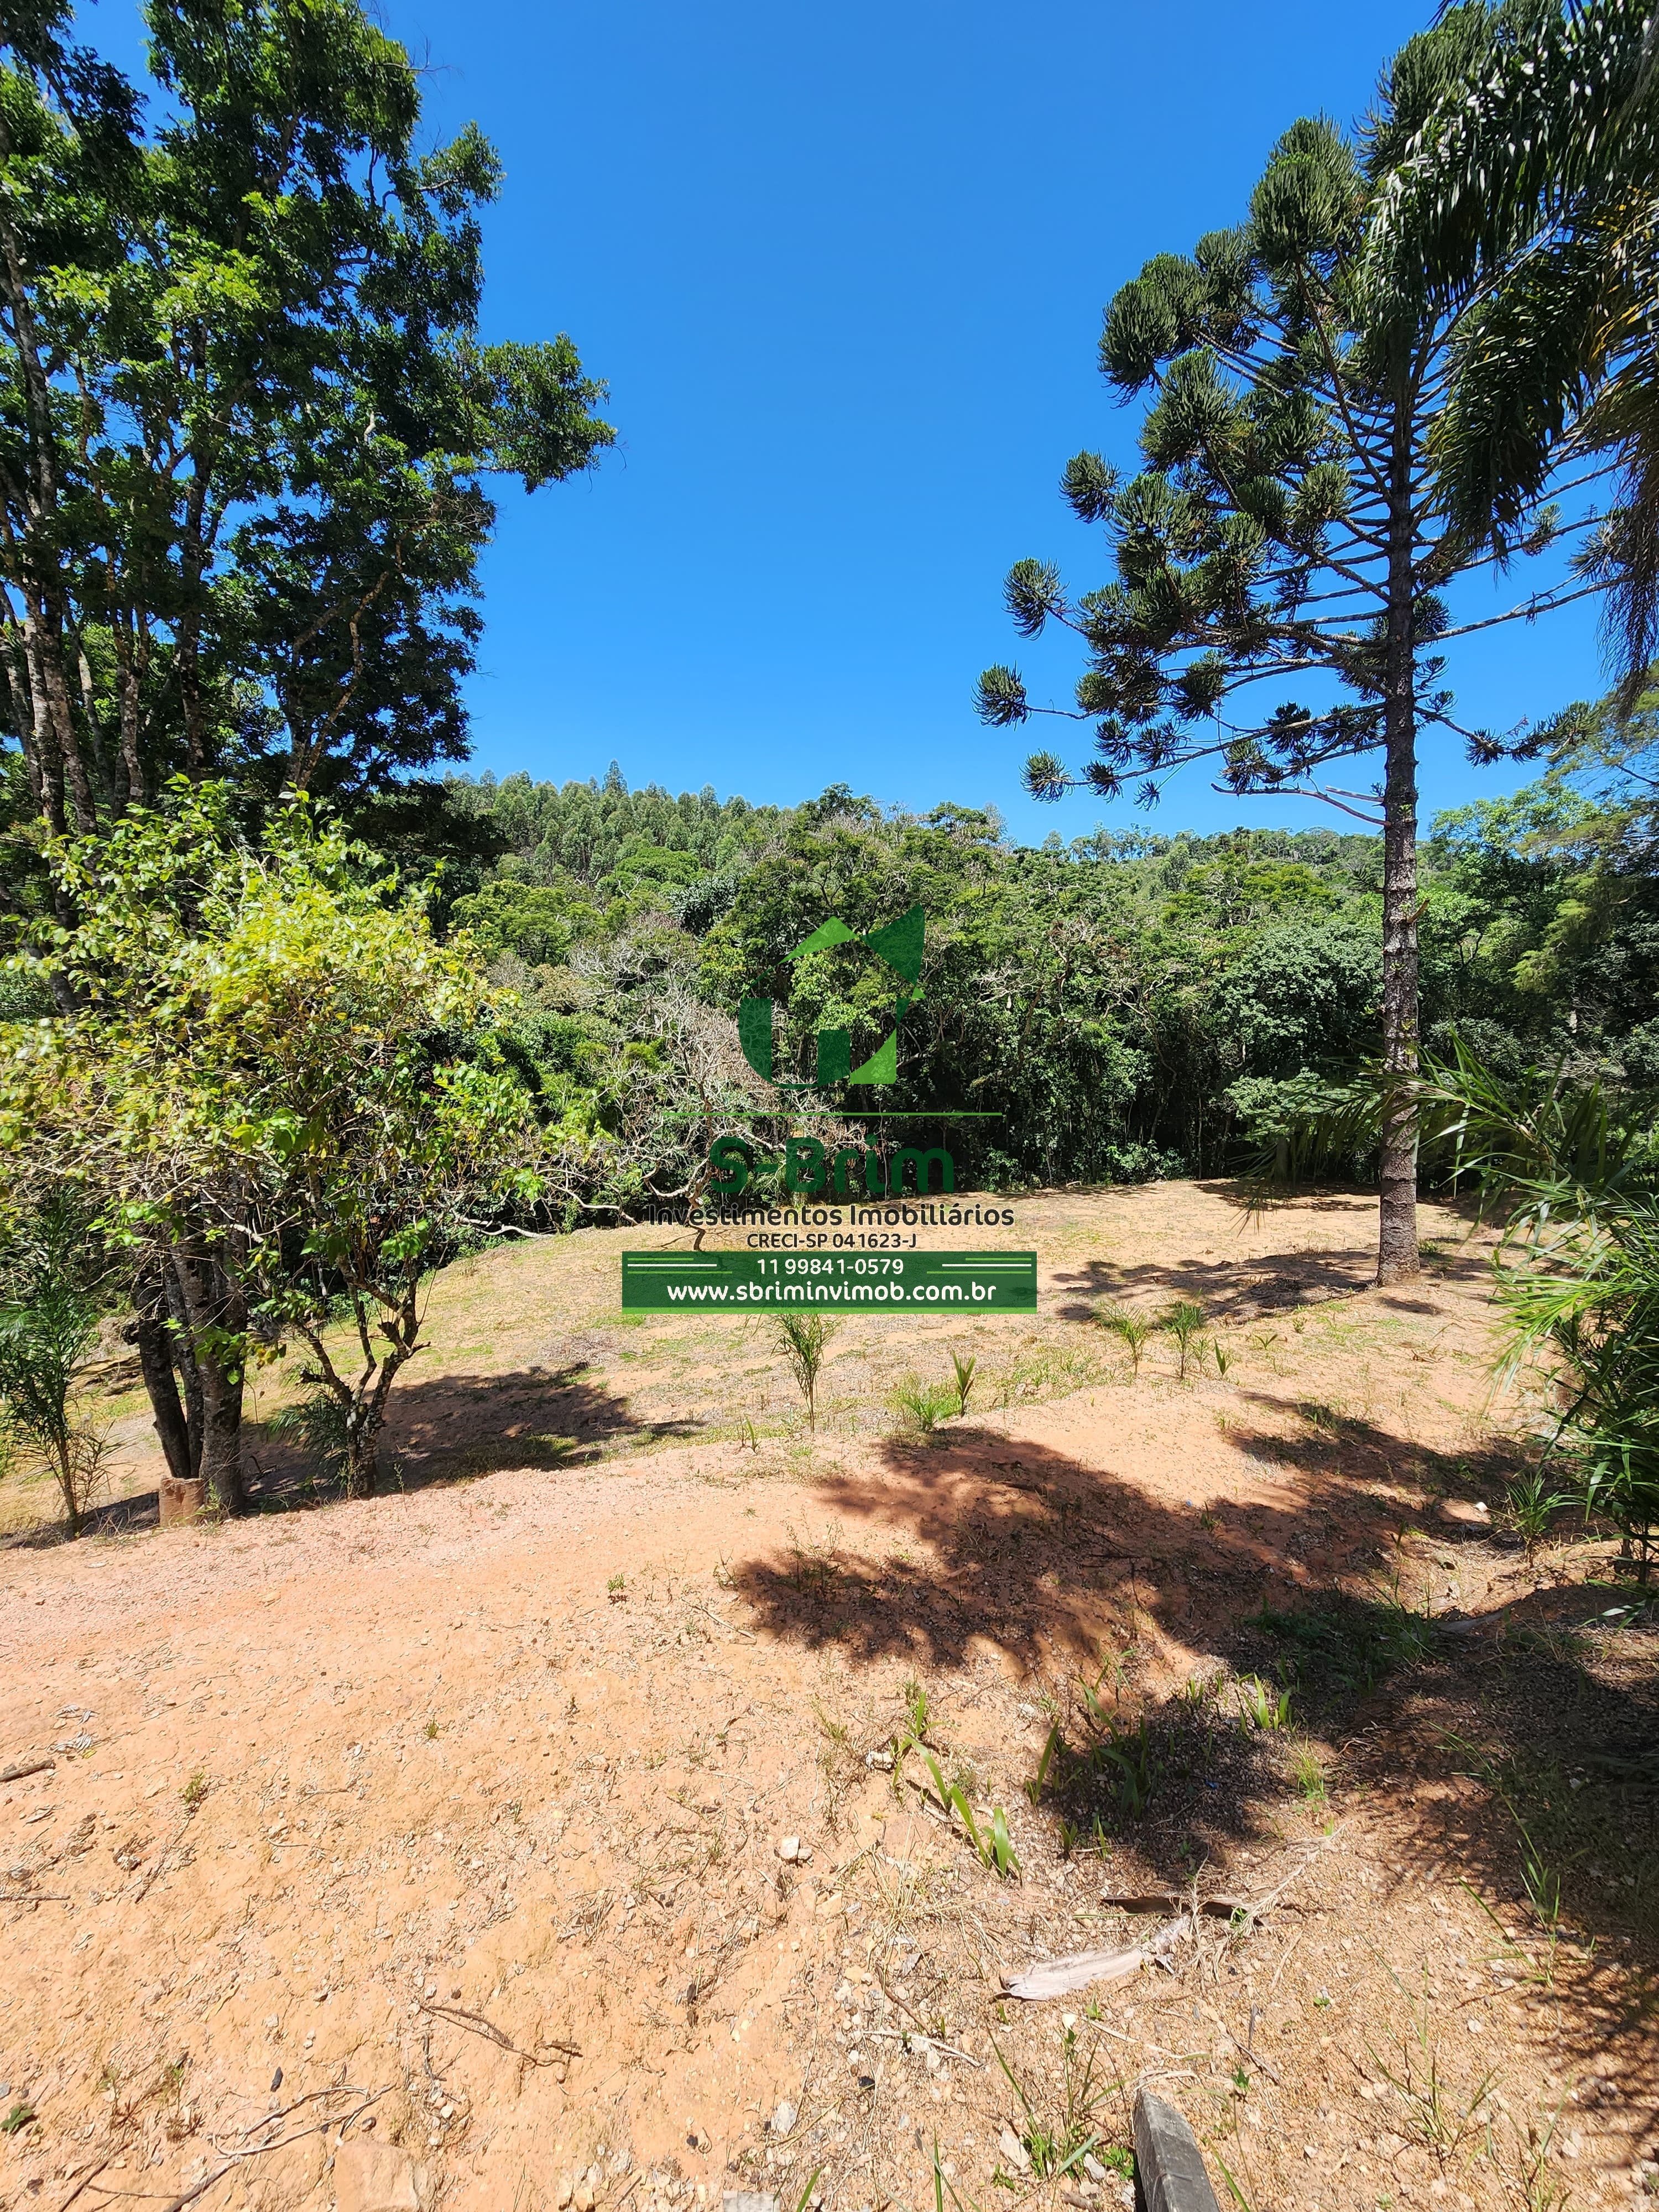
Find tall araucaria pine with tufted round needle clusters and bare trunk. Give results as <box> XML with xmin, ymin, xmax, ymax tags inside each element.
<box><xmin>978</xmin><ymin>7</ymin><xmax>1595</xmax><ymax>1283</ymax></box>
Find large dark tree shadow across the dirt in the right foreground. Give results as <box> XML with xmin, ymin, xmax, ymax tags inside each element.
<box><xmin>734</xmin><ymin>1425</ymin><xmax>1659</xmax><ymax>1991</ymax></box>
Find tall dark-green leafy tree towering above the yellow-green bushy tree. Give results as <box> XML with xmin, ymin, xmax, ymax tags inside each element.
<box><xmin>0</xmin><ymin>0</ymin><xmax>613</xmax><ymax>836</ymax></box>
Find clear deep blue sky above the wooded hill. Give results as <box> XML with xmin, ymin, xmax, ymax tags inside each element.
<box><xmin>88</xmin><ymin>0</ymin><xmax>1601</xmax><ymax>841</ymax></box>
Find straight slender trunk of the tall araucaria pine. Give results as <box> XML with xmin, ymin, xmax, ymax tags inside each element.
<box><xmin>1376</xmin><ymin>409</ymin><xmax>1418</xmax><ymax>1283</ymax></box>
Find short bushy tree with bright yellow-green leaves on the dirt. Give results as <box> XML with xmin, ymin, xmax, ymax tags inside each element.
<box><xmin>0</xmin><ymin>785</ymin><xmax>538</xmax><ymax>1511</ymax></box>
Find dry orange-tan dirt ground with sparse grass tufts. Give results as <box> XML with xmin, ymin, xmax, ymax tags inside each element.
<box><xmin>0</xmin><ymin>1183</ymin><xmax>1659</xmax><ymax>2212</ymax></box>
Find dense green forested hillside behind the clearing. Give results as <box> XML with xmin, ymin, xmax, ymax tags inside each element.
<box><xmin>438</xmin><ymin>743</ymin><xmax>1659</xmax><ymax>1219</ymax></box>
